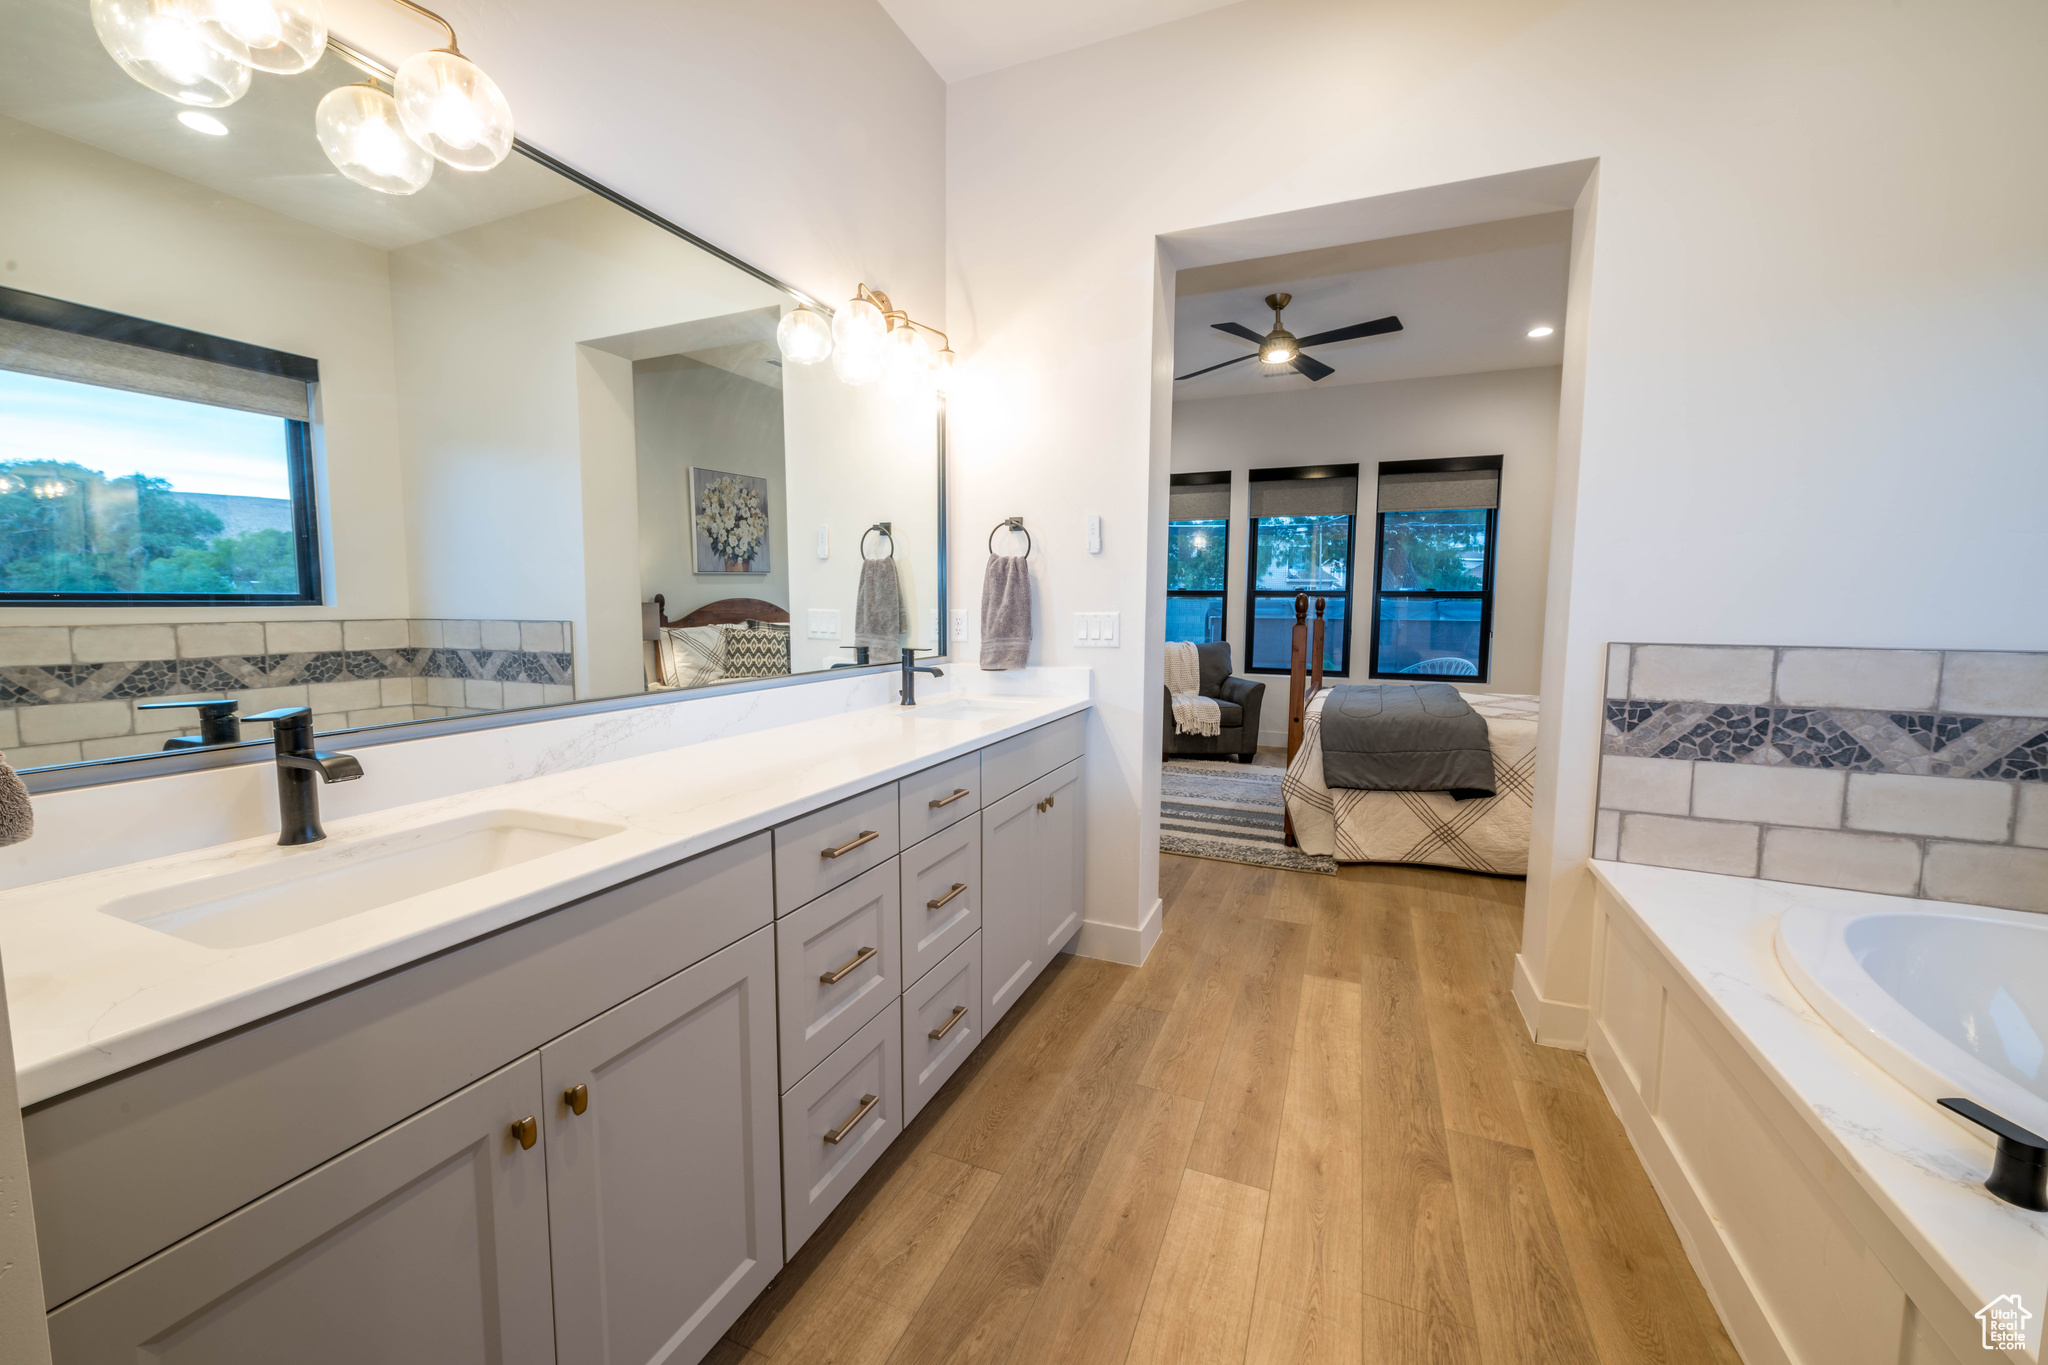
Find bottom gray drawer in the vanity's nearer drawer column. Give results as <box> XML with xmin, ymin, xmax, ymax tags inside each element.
<box><xmin>782</xmin><ymin>1001</ymin><xmax>903</xmax><ymax>1259</ymax></box>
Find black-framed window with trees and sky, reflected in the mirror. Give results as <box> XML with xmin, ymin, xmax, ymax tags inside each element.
<box><xmin>0</xmin><ymin>289</ymin><xmax>319</xmax><ymax>606</ymax></box>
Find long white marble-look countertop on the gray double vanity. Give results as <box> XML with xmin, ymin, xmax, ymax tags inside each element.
<box><xmin>0</xmin><ymin>692</ymin><xmax>1090</xmax><ymax>1105</ymax></box>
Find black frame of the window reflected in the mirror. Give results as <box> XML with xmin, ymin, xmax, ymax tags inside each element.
<box><xmin>0</xmin><ymin>289</ymin><xmax>326</xmax><ymax>606</ymax></box>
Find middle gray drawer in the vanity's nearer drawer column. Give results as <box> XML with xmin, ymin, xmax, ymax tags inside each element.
<box><xmin>774</xmin><ymin>862</ymin><xmax>903</xmax><ymax>1091</ymax></box>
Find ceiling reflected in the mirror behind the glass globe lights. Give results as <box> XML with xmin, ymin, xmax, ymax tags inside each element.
<box><xmin>0</xmin><ymin>0</ymin><xmax>590</xmax><ymax>250</ymax></box>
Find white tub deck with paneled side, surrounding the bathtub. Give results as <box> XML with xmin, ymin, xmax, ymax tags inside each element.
<box><xmin>1589</xmin><ymin>862</ymin><xmax>2048</xmax><ymax>1365</ymax></box>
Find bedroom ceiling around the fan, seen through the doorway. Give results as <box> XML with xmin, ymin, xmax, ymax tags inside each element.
<box><xmin>1174</xmin><ymin>215</ymin><xmax>1571</xmax><ymax>401</ymax></box>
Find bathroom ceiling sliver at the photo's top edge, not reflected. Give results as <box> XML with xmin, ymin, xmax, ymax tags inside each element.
<box><xmin>883</xmin><ymin>0</ymin><xmax>1235</xmax><ymax>82</ymax></box>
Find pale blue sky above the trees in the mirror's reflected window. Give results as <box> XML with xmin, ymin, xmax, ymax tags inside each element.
<box><xmin>0</xmin><ymin>370</ymin><xmax>291</xmax><ymax>497</ymax></box>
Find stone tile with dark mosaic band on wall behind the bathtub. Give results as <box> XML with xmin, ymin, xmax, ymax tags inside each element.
<box><xmin>1593</xmin><ymin>645</ymin><xmax>2048</xmax><ymax>913</ymax></box>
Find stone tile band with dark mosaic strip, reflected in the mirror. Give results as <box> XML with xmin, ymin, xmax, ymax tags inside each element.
<box><xmin>0</xmin><ymin>618</ymin><xmax>575</xmax><ymax>767</ymax></box>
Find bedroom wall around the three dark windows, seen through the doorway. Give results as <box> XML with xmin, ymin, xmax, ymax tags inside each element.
<box><xmin>1174</xmin><ymin>366</ymin><xmax>1559</xmax><ymax>724</ymax></box>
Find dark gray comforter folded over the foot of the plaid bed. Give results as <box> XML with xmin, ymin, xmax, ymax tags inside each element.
<box><xmin>1323</xmin><ymin>684</ymin><xmax>1493</xmax><ymax>800</ymax></box>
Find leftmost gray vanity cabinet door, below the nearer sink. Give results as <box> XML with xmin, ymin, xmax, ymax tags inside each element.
<box><xmin>49</xmin><ymin>1054</ymin><xmax>555</xmax><ymax>1365</ymax></box>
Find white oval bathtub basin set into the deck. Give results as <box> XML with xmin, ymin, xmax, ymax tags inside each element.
<box><xmin>1776</xmin><ymin>905</ymin><xmax>2048</xmax><ymax>1134</ymax></box>
